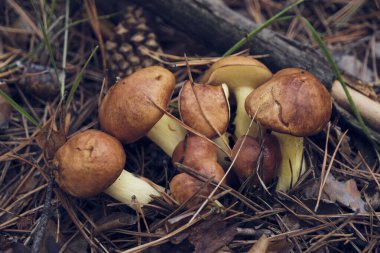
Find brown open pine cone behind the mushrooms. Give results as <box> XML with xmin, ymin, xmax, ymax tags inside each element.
<box><xmin>105</xmin><ymin>5</ymin><xmax>162</xmax><ymax>78</ymax></box>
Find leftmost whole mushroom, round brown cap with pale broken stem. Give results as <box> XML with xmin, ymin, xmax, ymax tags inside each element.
<box><xmin>54</xmin><ymin>130</ymin><xmax>161</xmax><ymax>208</ymax></box>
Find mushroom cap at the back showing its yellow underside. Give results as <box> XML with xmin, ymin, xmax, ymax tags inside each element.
<box><xmin>202</xmin><ymin>56</ymin><xmax>272</xmax><ymax>89</ymax></box>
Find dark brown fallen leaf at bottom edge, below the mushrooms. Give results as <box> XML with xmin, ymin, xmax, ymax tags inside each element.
<box><xmin>189</xmin><ymin>215</ymin><xmax>238</xmax><ymax>252</ymax></box>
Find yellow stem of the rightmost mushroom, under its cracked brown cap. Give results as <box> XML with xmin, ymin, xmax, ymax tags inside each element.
<box><xmin>272</xmin><ymin>132</ymin><xmax>306</xmax><ymax>192</ymax></box>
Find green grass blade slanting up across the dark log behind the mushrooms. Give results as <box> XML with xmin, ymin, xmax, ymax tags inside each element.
<box><xmin>223</xmin><ymin>0</ymin><xmax>305</xmax><ymax>57</ymax></box>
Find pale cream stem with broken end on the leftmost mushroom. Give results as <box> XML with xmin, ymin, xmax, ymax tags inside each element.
<box><xmin>104</xmin><ymin>170</ymin><xmax>164</xmax><ymax>210</ymax></box>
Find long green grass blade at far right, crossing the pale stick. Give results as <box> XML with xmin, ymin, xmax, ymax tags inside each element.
<box><xmin>300</xmin><ymin>17</ymin><xmax>378</xmax><ymax>148</ymax></box>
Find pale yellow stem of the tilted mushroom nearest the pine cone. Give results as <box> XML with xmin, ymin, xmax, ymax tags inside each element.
<box><xmin>146</xmin><ymin>114</ymin><xmax>186</xmax><ymax>157</ymax></box>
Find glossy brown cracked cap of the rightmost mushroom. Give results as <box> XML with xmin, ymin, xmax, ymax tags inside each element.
<box><xmin>245</xmin><ymin>68</ymin><xmax>332</xmax><ymax>136</ymax></box>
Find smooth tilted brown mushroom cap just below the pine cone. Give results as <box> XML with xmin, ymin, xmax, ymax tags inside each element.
<box><xmin>99</xmin><ymin>66</ymin><xmax>175</xmax><ymax>143</ymax></box>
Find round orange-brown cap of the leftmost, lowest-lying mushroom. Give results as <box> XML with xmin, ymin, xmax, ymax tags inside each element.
<box><xmin>55</xmin><ymin>130</ymin><xmax>125</xmax><ymax>198</ymax></box>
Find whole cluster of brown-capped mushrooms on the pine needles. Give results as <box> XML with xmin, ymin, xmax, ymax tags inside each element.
<box><xmin>55</xmin><ymin>56</ymin><xmax>332</xmax><ymax>211</ymax></box>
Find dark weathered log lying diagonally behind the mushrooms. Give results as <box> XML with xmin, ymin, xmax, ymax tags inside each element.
<box><xmin>134</xmin><ymin>0</ymin><xmax>334</xmax><ymax>88</ymax></box>
